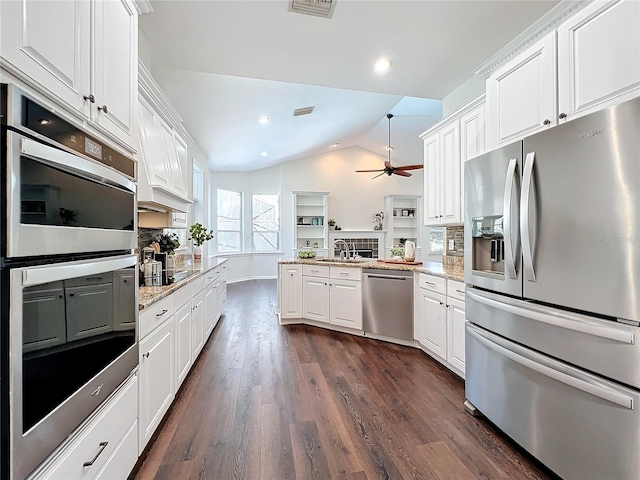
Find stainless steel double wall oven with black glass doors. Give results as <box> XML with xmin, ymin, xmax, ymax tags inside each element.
<box><xmin>0</xmin><ymin>84</ymin><xmax>138</xmax><ymax>480</ymax></box>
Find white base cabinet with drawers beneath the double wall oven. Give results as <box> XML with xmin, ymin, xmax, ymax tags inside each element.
<box><xmin>32</xmin><ymin>374</ymin><xmax>138</xmax><ymax>480</ymax></box>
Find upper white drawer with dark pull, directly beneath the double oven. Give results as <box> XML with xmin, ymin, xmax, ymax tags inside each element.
<box><xmin>35</xmin><ymin>374</ymin><xmax>138</xmax><ymax>480</ymax></box>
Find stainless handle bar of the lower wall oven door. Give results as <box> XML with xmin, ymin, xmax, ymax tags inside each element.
<box><xmin>22</xmin><ymin>255</ymin><xmax>138</xmax><ymax>287</ymax></box>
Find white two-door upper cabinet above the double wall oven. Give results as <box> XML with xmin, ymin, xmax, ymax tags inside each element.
<box><xmin>0</xmin><ymin>0</ymin><xmax>138</xmax><ymax>151</ymax></box>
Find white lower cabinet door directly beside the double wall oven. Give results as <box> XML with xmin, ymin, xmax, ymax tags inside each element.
<box><xmin>138</xmin><ymin>315</ymin><xmax>176</xmax><ymax>453</ymax></box>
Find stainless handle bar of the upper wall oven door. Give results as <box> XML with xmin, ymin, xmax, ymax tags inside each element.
<box><xmin>18</xmin><ymin>132</ymin><xmax>136</xmax><ymax>194</ymax></box>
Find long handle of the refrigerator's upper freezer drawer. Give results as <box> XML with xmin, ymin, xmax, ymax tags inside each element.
<box><xmin>467</xmin><ymin>292</ymin><xmax>635</xmax><ymax>345</ymax></box>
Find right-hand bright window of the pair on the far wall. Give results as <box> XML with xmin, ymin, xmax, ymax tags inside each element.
<box><xmin>251</xmin><ymin>195</ymin><xmax>280</xmax><ymax>252</ymax></box>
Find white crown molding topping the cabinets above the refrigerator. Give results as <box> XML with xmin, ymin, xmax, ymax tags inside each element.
<box><xmin>473</xmin><ymin>0</ymin><xmax>596</xmax><ymax>78</ymax></box>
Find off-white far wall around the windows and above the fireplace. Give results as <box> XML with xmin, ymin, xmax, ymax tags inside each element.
<box><xmin>212</xmin><ymin>147</ymin><xmax>442</xmax><ymax>281</ymax></box>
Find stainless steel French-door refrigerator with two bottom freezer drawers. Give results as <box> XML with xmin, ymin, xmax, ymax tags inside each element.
<box><xmin>464</xmin><ymin>98</ymin><xmax>640</xmax><ymax>479</ymax></box>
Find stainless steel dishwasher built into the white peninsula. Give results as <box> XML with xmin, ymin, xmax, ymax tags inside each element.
<box><xmin>362</xmin><ymin>268</ymin><xmax>413</xmax><ymax>340</ymax></box>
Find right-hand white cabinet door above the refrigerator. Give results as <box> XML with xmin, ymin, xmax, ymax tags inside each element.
<box><xmin>558</xmin><ymin>1</ymin><xmax>640</xmax><ymax>121</ymax></box>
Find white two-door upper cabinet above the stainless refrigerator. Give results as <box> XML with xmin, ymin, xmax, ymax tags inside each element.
<box><xmin>476</xmin><ymin>0</ymin><xmax>640</xmax><ymax>149</ymax></box>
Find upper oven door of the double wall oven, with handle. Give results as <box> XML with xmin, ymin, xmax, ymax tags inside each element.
<box><xmin>6</xmin><ymin>131</ymin><xmax>137</xmax><ymax>257</ymax></box>
